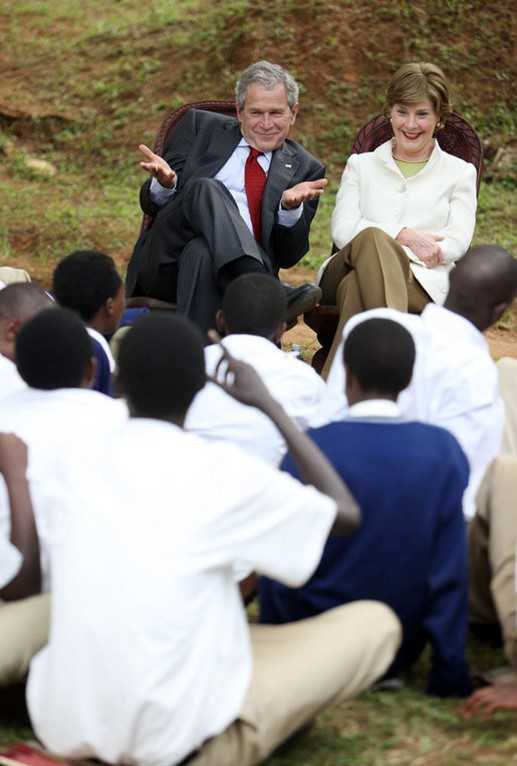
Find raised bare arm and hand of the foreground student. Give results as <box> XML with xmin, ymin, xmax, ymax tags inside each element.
<box><xmin>210</xmin><ymin>344</ymin><xmax>360</xmax><ymax>535</ymax></box>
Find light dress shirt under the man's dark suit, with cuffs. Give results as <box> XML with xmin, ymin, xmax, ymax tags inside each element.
<box><xmin>149</xmin><ymin>138</ymin><xmax>303</xmax><ymax>234</ymax></box>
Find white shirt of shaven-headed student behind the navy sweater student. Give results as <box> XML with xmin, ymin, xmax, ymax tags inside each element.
<box><xmin>327</xmin><ymin>303</ymin><xmax>504</xmax><ymax>518</ymax></box>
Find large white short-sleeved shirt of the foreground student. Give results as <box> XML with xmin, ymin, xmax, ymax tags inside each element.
<box><xmin>28</xmin><ymin>419</ymin><xmax>335</xmax><ymax>766</ymax></box>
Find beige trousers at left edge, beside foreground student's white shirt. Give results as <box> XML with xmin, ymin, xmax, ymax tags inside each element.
<box><xmin>0</xmin><ymin>593</ymin><xmax>50</xmax><ymax>686</ymax></box>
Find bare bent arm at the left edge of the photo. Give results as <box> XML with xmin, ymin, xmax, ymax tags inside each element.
<box><xmin>0</xmin><ymin>433</ymin><xmax>41</xmax><ymax>601</ymax></box>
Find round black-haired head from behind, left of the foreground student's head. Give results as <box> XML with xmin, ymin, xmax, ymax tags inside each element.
<box><xmin>15</xmin><ymin>307</ymin><xmax>93</xmax><ymax>391</ymax></box>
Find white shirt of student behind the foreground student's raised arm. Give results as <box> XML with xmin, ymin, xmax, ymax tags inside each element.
<box><xmin>185</xmin><ymin>335</ymin><xmax>328</xmax><ymax>465</ymax></box>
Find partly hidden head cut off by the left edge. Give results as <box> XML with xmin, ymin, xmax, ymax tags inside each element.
<box><xmin>0</xmin><ymin>282</ymin><xmax>53</xmax><ymax>362</ymax></box>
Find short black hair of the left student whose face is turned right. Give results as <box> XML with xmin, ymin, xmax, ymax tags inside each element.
<box><xmin>52</xmin><ymin>250</ymin><xmax>122</xmax><ymax>322</ymax></box>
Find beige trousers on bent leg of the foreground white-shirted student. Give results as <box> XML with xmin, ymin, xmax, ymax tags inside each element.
<box><xmin>190</xmin><ymin>601</ymin><xmax>401</xmax><ymax>766</ymax></box>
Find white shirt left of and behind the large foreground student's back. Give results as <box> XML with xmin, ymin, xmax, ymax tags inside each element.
<box><xmin>0</xmin><ymin>387</ymin><xmax>128</xmax><ymax>590</ymax></box>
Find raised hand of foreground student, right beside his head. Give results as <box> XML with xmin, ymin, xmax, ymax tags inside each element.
<box><xmin>208</xmin><ymin>332</ymin><xmax>274</xmax><ymax>410</ymax></box>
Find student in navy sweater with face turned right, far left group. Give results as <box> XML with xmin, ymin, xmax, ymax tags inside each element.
<box><xmin>52</xmin><ymin>250</ymin><xmax>125</xmax><ymax>395</ymax></box>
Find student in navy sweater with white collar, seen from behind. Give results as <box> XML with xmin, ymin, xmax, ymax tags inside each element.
<box><xmin>259</xmin><ymin>319</ymin><xmax>470</xmax><ymax>696</ymax></box>
